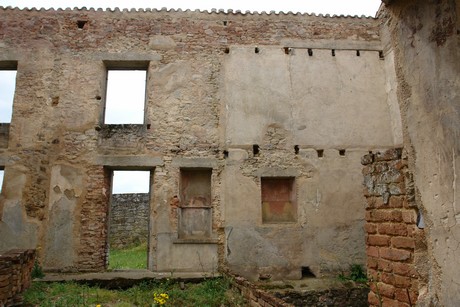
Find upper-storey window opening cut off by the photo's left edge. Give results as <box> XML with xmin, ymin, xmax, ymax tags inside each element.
<box><xmin>0</xmin><ymin>62</ymin><xmax>17</xmax><ymax>123</ymax></box>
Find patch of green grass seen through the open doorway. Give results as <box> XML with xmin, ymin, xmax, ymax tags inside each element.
<box><xmin>108</xmin><ymin>243</ymin><xmax>147</xmax><ymax>270</ymax></box>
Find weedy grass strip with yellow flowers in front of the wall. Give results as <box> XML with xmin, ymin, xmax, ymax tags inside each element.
<box><xmin>24</xmin><ymin>278</ymin><xmax>246</xmax><ymax>307</ymax></box>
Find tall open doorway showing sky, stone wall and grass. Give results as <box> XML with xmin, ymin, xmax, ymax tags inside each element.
<box><xmin>108</xmin><ymin>170</ymin><xmax>151</xmax><ymax>269</ymax></box>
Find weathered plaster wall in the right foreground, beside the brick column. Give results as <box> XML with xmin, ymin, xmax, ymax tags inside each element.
<box><xmin>380</xmin><ymin>0</ymin><xmax>460</xmax><ymax>306</ymax></box>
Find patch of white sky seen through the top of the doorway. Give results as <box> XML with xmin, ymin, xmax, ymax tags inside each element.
<box><xmin>112</xmin><ymin>171</ymin><xmax>150</xmax><ymax>194</ymax></box>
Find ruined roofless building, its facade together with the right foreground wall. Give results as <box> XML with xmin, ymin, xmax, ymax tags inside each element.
<box><xmin>0</xmin><ymin>0</ymin><xmax>460</xmax><ymax>306</ymax></box>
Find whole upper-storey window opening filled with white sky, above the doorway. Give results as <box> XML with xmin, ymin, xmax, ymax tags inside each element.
<box><xmin>104</xmin><ymin>63</ymin><xmax>148</xmax><ymax>125</ymax></box>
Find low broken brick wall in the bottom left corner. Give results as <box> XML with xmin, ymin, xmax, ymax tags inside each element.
<box><xmin>0</xmin><ymin>249</ymin><xmax>35</xmax><ymax>306</ymax></box>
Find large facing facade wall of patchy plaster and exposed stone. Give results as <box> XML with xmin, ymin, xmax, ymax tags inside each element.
<box><xmin>0</xmin><ymin>8</ymin><xmax>401</xmax><ymax>279</ymax></box>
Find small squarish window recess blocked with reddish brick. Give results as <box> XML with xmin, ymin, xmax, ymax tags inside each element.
<box><xmin>261</xmin><ymin>177</ymin><xmax>297</xmax><ymax>223</ymax></box>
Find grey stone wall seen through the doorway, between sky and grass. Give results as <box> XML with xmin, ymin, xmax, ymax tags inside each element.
<box><xmin>109</xmin><ymin>193</ymin><xmax>150</xmax><ymax>248</ymax></box>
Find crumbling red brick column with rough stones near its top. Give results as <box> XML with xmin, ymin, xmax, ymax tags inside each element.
<box><xmin>361</xmin><ymin>148</ymin><xmax>423</xmax><ymax>306</ymax></box>
